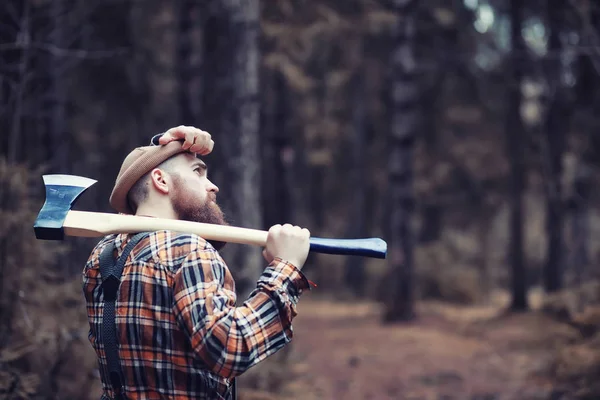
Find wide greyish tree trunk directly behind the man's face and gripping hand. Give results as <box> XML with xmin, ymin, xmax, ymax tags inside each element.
<box><xmin>203</xmin><ymin>0</ymin><xmax>264</xmax><ymax>298</ymax></box>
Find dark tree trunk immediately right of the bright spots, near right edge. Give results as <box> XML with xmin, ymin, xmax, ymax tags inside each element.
<box><xmin>543</xmin><ymin>2</ymin><xmax>571</xmax><ymax>293</ymax></box>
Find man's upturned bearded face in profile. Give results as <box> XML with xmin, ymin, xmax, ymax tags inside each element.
<box><xmin>170</xmin><ymin>153</ymin><xmax>227</xmax><ymax>225</ymax></box>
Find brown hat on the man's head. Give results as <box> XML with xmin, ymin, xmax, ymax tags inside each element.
<box><xmin>110</xmin><ymin>141</ymin><xmax>187</xmax><ymax>214</ymax></box>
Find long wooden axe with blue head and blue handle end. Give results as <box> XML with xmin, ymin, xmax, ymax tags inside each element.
<box><xmin>33</xmin><ymin>175</ymin><xmax>387</xmax><ymax>259</ymax></box>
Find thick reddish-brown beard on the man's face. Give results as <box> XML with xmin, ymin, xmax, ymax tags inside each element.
<box><xmin>171</xmin><ymin>176</ymin><xmax>229</xmax><ymax>250</ymax></box>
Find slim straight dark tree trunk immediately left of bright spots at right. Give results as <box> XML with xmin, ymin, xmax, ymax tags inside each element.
<box><xmin>506</xmin><ymin>0</ymin><xmax>528</xmax><ymax>311</ymax></box>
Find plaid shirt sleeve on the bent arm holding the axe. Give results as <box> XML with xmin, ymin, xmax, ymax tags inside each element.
<box><xmin>174</xmin><ymin>245</ymin><xmax>310</xmax><ymax>378</ymax></box>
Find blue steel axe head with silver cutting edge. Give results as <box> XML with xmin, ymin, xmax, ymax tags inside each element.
<box><xmin>33</xmin><ymin>175</ymin><xmax>97</xmax><ymax>240</ymax></box>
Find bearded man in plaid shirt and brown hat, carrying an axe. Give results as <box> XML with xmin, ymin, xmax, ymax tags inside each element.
<box><xmin>83</xmin><ymin>126</ymin><xmax>310</xmax><ymax>400</ymax></box>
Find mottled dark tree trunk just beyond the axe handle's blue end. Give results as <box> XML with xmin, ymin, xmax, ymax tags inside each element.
<box><xmin>384</xmin><ymin>0</ymin><xmax>423</xmax><ymax>322</ymax></box>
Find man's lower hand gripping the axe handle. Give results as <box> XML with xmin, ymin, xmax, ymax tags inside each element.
<box><xmin>263</xmin><ymin>224</ymin><xmax>310</xmax><ymax>269</ymax></box>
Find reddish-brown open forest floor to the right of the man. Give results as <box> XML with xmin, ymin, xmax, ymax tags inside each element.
<box><xmin>240</xmin><ymin>295</ymin><xmax>576</xmax><ymax>400</ymax></box>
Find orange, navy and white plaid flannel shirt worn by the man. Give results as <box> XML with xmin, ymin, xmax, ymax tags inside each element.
<box><xmin>83</xmin><ymin>231</ymin><xmax>310</xmax><ymax>400</ymax></box>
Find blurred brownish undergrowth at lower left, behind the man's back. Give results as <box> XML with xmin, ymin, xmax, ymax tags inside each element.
<box><xmin>0</xmin><ymin>157</ymin><xmax>97</xmax><ymax>399</ymax></box>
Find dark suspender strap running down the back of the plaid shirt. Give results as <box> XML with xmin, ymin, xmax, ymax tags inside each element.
<box><xmin>100</xmin><ymin>232</ymin><xmax>149</xmax><ymax>400</ymax></box>
